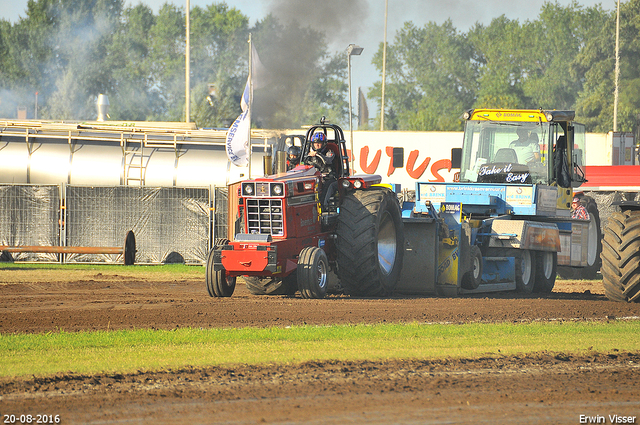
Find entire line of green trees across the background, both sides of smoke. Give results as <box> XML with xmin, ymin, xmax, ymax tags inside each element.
<box><xmin>0</xmin><ymin>0</ymin><xmax>640</xmax><ymax>132</ymax></box>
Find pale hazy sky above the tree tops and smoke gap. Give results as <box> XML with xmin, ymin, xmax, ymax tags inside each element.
<box><xmin>0</xmin><ymin>0</ymin><xmax>617</xmax><ymax>109</ymax></box>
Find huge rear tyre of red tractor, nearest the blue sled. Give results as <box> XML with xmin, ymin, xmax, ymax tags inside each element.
<box><xmin>336</xmin><ymin>187</ymin><xmax>404</xmax><ymax>297</ymax></box>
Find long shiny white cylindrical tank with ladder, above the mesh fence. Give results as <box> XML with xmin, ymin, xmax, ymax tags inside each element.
<box><xmin>0</xmin><ymin>121</ymin><xmax>278</xmax><ymax>187</ymax></box>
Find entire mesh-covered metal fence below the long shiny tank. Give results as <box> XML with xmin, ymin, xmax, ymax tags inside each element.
<box><xmin>0</xmin><ymin>185</ymin><xmax>222</xmax><ymax>264</ymax></box>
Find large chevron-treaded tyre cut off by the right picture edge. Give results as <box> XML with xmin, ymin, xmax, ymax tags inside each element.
<box><xmin>602</xmin><ymin>211</ymin><xmax>640</xmax><ymax>302</ymax></box>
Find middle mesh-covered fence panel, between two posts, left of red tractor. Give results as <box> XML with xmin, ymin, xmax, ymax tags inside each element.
<box><xmin>65</xmin><ymin>186</ymin><xmax>211</xmax><ymax>263</ymax></box>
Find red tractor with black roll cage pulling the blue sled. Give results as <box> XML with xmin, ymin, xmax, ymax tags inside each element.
<box><xmin>206</xmin><ymin>117</ymin><xmax>404</xmax><ymax>298</ymax></box>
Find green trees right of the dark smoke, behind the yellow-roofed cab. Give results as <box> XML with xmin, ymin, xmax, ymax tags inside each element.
<box><xmin>369</xmin><ymin>0</ymin><xmax>640</xmax><ymax>132</ymax></box>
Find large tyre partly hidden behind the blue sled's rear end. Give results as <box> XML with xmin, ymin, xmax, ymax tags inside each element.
<box><xmin>558</xmin><ymin>196</ymin><xmax>602</xmax><ymax>279</ymax></box>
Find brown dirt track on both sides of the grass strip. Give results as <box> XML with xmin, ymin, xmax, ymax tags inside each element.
<box><xmin>0</xmin><ymin>270</ymin><xmax>640</xmax><ymax>424</ymax></box>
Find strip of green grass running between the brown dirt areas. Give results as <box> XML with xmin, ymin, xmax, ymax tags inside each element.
<box><xmin>0</xmin><ymin>321</ymin><xmax>640</xmax><ymax>377</ymax></box>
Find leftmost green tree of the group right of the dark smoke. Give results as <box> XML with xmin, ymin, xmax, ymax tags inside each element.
<box><xmin>369</xmin><ymin>20</ymin><xmax>477</xmax><ymax>130</ymax></box>
